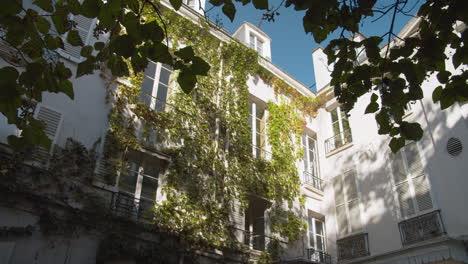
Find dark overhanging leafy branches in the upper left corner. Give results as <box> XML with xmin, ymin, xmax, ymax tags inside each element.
<box><xmin>0</xmin><ymin>0</ymin><xmax>210</xmax><ymax>149</ymax></box>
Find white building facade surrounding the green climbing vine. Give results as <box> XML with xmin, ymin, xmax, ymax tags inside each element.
<box><xmin>0</xmin><ymin>0</ymin><xmax>468</xmax><ymax>264</ymax></box>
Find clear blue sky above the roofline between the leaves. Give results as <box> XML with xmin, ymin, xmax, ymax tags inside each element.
<box><xmin>207</xmin><ymin>0</ymin><xmax>424</xmax><ymax>90</ymax></box>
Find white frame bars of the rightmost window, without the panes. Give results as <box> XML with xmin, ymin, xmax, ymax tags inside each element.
<box><xmin>388</xmin><ymin>142</ymin><xmax>438</xmax><ymax>221</ymax></box>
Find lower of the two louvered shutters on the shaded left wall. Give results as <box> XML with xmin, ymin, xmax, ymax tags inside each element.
<box><xmin>32</xmin><ymin>105</ymin><xmax>62</xmax><ymax>166</ymax></box>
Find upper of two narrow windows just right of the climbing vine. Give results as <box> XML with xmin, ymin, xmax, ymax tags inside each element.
<box><xmin>302</xmin><ymin>134</ymin><xmax>322</xmax><ymax>190</ymax></box>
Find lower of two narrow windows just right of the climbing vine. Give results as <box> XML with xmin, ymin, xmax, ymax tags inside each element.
<box><xmin>308</xmin><ymin>216</ymin><xmax>326</xmax><ymax>262</ymax></box>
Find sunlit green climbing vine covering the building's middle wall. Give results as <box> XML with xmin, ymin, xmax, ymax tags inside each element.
<box><xmin>98</xmin><ymin>7</ymin><xmax>319</xmax><ymax>259</ymax></box>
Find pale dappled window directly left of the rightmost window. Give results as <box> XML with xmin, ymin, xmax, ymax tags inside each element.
<box><xmin>333</xmin><ymin>169</ymin><xmax>362</xmax><ymax>236</ymax></box>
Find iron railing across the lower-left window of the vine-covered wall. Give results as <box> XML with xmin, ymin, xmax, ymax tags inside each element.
<box><xmin>110</xmin><ymin>192</ymin><xmax>154</xmax><ymax>220</ymax></box>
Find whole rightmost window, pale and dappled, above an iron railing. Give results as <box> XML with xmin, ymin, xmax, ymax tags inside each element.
<box><xmin>391</xmin><ymin>142</ymin><xmax>432</xmax><ymax>218</ymax></box>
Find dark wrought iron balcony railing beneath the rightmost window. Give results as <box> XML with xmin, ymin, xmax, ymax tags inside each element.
<box><xmin>398</xmin><ymin>210</ymin><xmax>445</xmax><ymax>245</ymax></box>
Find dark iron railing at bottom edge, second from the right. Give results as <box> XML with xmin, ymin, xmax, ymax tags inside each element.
<box><xmin>336</xmin><ymin>233</ymin><xmax>370</xmax><ymax>260</ymax></box>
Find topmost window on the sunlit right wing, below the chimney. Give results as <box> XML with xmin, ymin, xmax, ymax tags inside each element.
<box><xmin>325</xmin><ymin>107</ymin><xmax>353</xmax><ymax>153</ymax></box>
